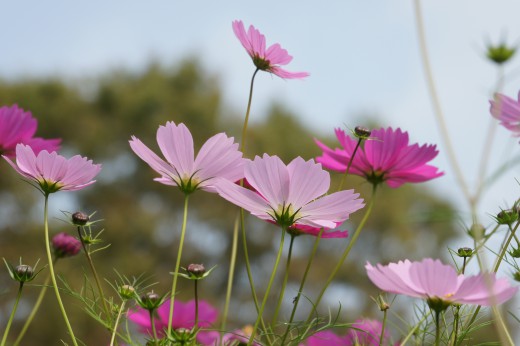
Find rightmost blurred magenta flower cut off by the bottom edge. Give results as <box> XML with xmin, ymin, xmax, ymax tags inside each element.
<box><xmin>344</xmin><ymin>319</ymin><xmax>390</xmax><ymax>346</ymax></box>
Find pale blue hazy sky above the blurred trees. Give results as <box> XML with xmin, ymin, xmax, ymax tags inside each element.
<box><xmin>0</xmin><ymin>0</ymin><xmax>520</xmax><ymax>227</ymax></box>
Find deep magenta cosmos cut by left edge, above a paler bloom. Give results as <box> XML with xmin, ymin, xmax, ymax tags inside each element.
<box><xmin>0</xmin><ymin>105</ymin><xmax>61</xmax><ymax>157</ymax></box>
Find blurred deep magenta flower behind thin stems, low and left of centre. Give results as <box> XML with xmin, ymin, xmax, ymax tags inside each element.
<box><xmin>128</xmin><ymin>299</ymin><xmax>218</xmax><ymax>342</ymax></box>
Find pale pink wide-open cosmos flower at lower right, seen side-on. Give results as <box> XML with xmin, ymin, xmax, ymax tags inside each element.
<box><xmin>365</xmin><ymin>258</ymin><xmax>518</xmax><ymax>307</ymax></box>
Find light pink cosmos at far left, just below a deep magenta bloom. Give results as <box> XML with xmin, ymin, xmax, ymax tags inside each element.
<box><xmin>3</xmin><ymin>144</ymin><xmax>101</xmax><ymax>195</ymax></box>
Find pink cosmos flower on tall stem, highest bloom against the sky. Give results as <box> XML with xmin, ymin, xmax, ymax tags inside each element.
<box><xmin>233</xmin><ymin>20</ymin><xmax>309</xmax><ymax>79</ymax></box>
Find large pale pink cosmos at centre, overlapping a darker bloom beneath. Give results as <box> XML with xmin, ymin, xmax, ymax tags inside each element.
<box><xmin>216</xmin><ymin>154</ymin><xmax>364</xmax><ymax>229</ymax></box>
